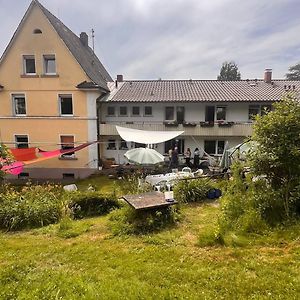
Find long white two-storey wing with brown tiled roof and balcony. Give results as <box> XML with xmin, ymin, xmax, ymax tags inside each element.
<box><xmin>99</xmin><ymin>75</ymin><xmax>300</xmax><ymax>163</ymax></box>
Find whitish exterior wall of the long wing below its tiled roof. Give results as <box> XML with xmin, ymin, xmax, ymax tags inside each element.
<box><xmin>99</xmin><ymin>102</ymin><xmax>267</xmax><ymax>164</ymax></box>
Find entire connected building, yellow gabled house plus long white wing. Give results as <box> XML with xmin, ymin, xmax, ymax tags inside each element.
<box><xmin>0</xmin><ymin>0</ymin><xmax>300</xmax><ymax>179</ymax></box>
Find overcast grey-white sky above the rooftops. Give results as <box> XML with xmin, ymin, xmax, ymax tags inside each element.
<box><xmin>0</xmin><ymin>0</ymin><xmax>300</xmax><ymax>79</ymax></box>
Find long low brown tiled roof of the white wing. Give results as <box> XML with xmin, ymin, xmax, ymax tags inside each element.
<box><xmin>106</xmin><ymin>80</ymin><xmax>300</xmax><ymax>102</ymax></box>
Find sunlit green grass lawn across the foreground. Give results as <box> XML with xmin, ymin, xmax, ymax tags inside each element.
<box><xmin>0</xmin><ymin>203</ymin><xmax>300</xmax><ymax>299</ymax></box>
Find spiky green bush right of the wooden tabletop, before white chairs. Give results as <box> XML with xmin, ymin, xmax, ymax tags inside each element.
<box><xmin>174</xmin><ymin>178</ymin><xmax>213</xmax><ymax>203</ymax></box>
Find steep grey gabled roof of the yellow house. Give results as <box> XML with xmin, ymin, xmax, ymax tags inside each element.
<box><xmin>0</xmin><ymin>0</ymin><xmax>113</xmax><ymax>91</ymax></box>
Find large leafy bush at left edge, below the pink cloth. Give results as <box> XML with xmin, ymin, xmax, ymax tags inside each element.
<box><xmin>0</xmin><ymin>185</ymin><xmax>65</xmax><ymax>230</ymax></box>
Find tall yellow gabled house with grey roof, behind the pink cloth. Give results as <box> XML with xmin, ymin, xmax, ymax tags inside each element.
<box><xmin>0</xmin><ymin>1</ymin><xmax>112</xmax><ymax>178</ymax></box>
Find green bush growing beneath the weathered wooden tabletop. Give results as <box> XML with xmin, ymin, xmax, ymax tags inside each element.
<box><xmin>110</xmin><ymin>206</ymin><xmax>180</xmax><ymax>235</ymax></box>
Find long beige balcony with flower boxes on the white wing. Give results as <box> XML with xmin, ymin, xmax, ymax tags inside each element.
<box><xmin>99</xmin><ymin>122</ymin><xmax>252</xmax><ymax>137</ymax></box>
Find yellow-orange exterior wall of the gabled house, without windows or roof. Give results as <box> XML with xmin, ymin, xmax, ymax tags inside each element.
<box><xmin>0</xmin><ymin>6</ymin><xmax>100</xmax><ymax>178</ymax></box>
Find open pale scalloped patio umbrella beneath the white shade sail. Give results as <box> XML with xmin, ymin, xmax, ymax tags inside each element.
<box><xmin>124</xmin><ymin>148</ymin><xmax>165</xmax><ymax>165</ymax></box>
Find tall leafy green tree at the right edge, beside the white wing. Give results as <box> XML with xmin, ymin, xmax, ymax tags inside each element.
<box><xmin>250</xmin><ymin>95</ymin><xmax>300</xmax><ymax>217</ymax></box>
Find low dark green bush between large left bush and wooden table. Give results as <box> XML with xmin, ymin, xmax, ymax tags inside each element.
<box><xmin>67</xmin><ymin>191</ymin><xmax>120</xmax><ymax>219</ymax></box>
